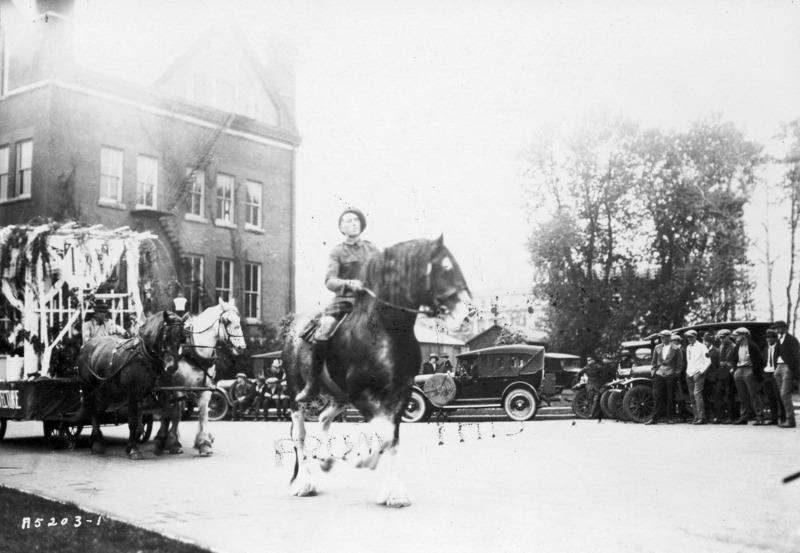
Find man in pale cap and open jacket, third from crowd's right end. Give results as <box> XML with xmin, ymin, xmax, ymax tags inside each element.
<box><xmin>729</xmin><ymin>327</ymin><xmax>764</xmax><ymax>426</ymax></box>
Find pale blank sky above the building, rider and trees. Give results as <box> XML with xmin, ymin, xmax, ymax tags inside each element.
<box><xmin>57</xmin><ymin>0</ymin><xmax>800</xmax><ymax>311</ymax></box>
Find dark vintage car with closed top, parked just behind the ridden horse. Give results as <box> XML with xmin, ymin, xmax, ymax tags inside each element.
<box><xmin>403</xmin><ymin>345</ymin><xmax>556</xmax><ymax>422</ymax></box>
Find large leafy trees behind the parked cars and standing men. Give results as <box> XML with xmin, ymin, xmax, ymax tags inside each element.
<box><xmin>524</xmin><ymin>117</ymin><xmax>763</xmax><ymax>355</ymax></box>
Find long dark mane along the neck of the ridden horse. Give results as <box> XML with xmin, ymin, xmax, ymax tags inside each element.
<box><xmin>362</xmin><ymin>238</ymin><xmax>433</xmax><ymax>308</ymax></box>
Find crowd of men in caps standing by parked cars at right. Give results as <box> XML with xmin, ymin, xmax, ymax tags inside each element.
<box><xmin>579</xmin><ymin>321</ymin><xmax>800</xmax><ymax>428</ymax></box>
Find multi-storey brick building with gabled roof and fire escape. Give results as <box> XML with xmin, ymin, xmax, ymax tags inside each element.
<box><xmin>0</xmin><ymin>0</ymin><xmax>300</xmax><ymax>338</ymax></box>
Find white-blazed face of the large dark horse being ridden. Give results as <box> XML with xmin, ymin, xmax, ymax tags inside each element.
<box><xmin>427</xmin><ymin>236</ymin><xmax>474</xmax><ymax>329</ymax></box>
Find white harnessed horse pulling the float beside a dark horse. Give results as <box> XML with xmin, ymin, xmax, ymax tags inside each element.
<box><xmin>154</xmin><ymin>298</ymin><xmax>247</xmax><ymax>456</ymax></box>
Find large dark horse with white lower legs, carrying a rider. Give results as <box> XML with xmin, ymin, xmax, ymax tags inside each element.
<box><xmin>283</xmin><ymin>237</ymin><xmax>470</xmax><ymax>507</ymax></box>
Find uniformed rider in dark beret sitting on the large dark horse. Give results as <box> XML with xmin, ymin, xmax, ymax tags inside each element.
<box><xmin>295</xmin><ymin>208</ymin><xmax>379</xmax><ymax>403</ymax></box>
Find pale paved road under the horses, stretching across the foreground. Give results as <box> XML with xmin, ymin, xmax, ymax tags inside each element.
<box><xmin>0</xmin><ymin>419</ymin><xmax>800</xmax><ymax>553</ymax></box>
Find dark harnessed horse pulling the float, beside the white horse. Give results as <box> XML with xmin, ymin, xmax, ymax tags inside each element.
<box><xmin>78</xmin><ymin>311</ymin><xmax>183</xmax><ymax>460</ymax></box>
